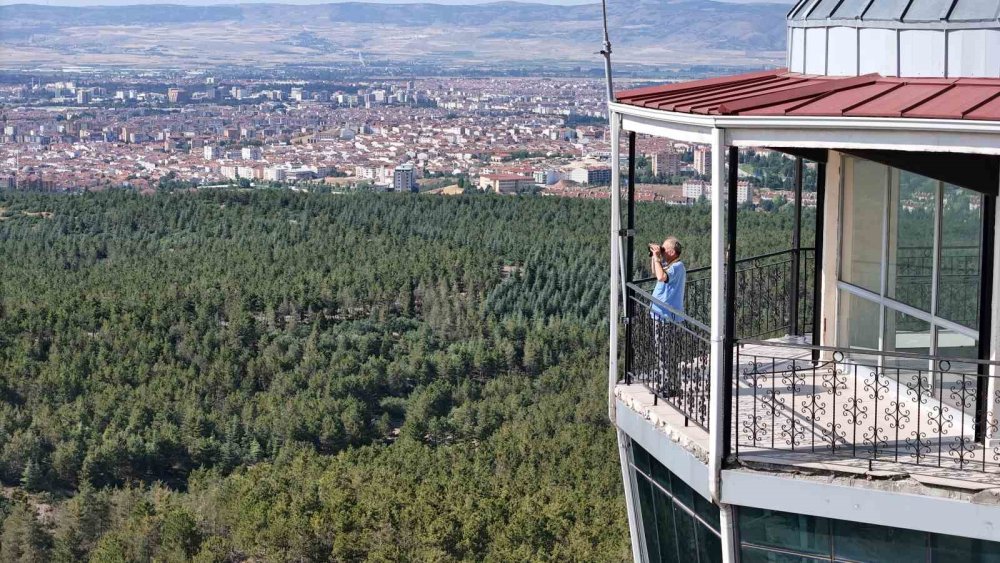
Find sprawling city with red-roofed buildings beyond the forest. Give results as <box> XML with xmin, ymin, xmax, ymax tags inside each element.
<box><xmin>0</xmin><ymin>72</ymin><xmax>813</xmax><ymax>207</ymax></box>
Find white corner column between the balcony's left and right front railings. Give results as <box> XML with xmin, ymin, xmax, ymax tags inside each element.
<box><xmin>708</xmin><ymin>129</ymin><xmax>727</xmax><ymax>502</ymax></box>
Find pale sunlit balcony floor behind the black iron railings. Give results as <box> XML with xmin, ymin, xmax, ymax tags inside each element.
<box><xmin>616</xmin><ymin>337</ymin><xmax>1000</xmax><ymax>491</ymax></box>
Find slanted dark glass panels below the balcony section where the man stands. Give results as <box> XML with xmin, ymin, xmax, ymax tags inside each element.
<box><xmin>630</xmin><ymin>442</ymin><xmax>722</xmax><ymax>563</ymax></box>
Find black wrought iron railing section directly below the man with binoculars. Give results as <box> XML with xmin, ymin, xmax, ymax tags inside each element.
<box><xmin>625</xmin><ymin>283</ymin><xmax>711</xmax><ymax>430</ymax></box>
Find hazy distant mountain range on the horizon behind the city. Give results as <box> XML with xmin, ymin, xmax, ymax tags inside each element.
<box><xmin>0</xmin><ymin>0</ymin><xmax>788</xmax><ymax>67</ymax></box>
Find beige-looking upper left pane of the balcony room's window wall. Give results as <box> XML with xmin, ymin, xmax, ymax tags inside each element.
<box><xmin>841</xmin><ymin>158</ymin><xmax>889</xmax><ymax>293</ymax></box>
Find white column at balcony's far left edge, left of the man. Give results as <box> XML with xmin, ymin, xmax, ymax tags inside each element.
<box><xmin>608</xmin><ymin>113</ymin><xmax>622</xmax><ymax>424</ymax></box>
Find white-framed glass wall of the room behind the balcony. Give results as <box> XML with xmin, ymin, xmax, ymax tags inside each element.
<box><xmin>838</xmin><ymin>157</ymin><xmax>985</xmax><ymax>367</ymax></box>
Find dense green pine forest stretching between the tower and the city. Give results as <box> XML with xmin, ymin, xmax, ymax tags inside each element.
<box><xmin>0</xmin><ymin>190</ymin><xmax>804</xmax><ymax>561</ymax></box>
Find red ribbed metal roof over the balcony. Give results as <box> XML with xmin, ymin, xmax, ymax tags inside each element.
<box><xmin>617</xmin><ymin>69</ymin><xmax>1000</xmax><ymax>121</ymax></box>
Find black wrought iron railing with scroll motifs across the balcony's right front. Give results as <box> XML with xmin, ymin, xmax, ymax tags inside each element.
<box><xmin>732</xmin><ymin>341</ymin><xmax>1000</xmax><ymax>473</ymax></box>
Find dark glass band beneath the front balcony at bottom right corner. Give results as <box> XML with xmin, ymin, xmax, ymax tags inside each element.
<box><xmin>737</xmin><ymin>507</ymin><xmax>1000</xmax><ymax>563</ymax></box>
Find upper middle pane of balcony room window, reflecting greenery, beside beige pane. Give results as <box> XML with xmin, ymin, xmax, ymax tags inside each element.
<box><xmin>886</xmin><ymin>169</ymin><xmax>938</xmax><ymax>312</ymax></box>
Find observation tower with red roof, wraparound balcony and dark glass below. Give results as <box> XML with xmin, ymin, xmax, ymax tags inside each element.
<box><xmin>608</xmin><ymin>0</ymin><xmax>1000</xmax><ymax>563</ymax></box>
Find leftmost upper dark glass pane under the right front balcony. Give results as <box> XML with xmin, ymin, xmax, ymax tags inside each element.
<box><xmin>739</xmin><ymin>507</ymin><xmax>831</xmax><ymax>557</ymax></box>
